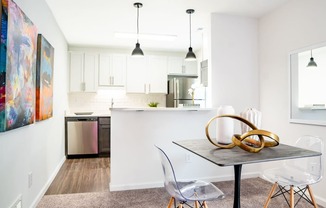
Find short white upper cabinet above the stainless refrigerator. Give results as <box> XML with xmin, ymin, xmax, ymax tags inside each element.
<box><xmin>168</xmin><ymin>56</ymin><xmax>198</xmax><ymax>76</ymax></box>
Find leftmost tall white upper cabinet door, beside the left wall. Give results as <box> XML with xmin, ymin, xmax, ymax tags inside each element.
<box><xmin>70</xmin><ymin>52</ymin><xmax>84</xmax><ymax>92</ymax></box>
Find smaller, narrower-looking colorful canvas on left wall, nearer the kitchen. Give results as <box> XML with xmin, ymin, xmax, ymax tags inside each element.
<box><xmin>36</xmin><ymin>34</ymin><xmax>54</xmax><ymax>121</ymax></box>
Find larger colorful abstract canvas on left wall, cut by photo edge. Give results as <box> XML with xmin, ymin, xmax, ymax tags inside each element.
<box><xmin>0</xmin><ymin>0</ymin><xmax>37</xmax><ymax>131</ymax></box>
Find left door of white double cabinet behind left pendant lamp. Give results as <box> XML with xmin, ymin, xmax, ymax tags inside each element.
<box><xmin>126</xmin><ymin>56</ymin><xmax>147</xmax><ymax>93</ymax></box>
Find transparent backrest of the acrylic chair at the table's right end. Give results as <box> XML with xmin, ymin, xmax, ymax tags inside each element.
<box><xmin>285</xmin><ymin>136</ymin><xmax>324</xmax><ymax>182</ymax></box>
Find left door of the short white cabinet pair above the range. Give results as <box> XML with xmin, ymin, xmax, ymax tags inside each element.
<box><xmin>98</xmin><ymin>54</ymin><xmax>112</xmax><ymax>86</ymax></box>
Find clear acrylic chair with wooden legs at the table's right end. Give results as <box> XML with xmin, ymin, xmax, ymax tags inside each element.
<box><xmin>263</xmin><ymin>136</ymin><xmax>324</xmax><ymax>208</ymax></box>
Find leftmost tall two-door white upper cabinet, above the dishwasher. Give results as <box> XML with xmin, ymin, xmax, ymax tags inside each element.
<box><xmin>70</xmin><ymin>52</ymin><xmax>98</xmax><ymax>92</ymax></box>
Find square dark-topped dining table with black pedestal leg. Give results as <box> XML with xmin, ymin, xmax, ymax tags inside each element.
<box><xmin>172</xmin><ymin>139</ymin><xmax>321</xmax><ymax>208</ymax></box>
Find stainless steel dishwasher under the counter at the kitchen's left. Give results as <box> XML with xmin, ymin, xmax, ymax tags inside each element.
<box><xmin>66</xmin><ymin>117</ymin><xmax>98</xmax><ymax>158</ymax></box>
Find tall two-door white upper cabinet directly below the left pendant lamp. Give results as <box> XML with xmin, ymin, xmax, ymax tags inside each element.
<box><xmin>126</xmin><ymin>56</ymin><xmax>167</xmax><ymax>94</ymax></box>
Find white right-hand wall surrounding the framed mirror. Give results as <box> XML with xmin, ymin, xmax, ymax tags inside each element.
<box><xmin>259</xmin><ymin>0</ymin><xmax>326</xmax><ymax>206</ymax></box>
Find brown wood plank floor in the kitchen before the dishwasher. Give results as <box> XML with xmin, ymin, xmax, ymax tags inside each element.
<box><xmin>45</xmin><ymin>157</ymin><xmax>110</xmax><ymax>195</ymax></box>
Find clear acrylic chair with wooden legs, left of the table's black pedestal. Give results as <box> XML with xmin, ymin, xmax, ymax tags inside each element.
<box><xmin>156</xmin><ymin>146</ymin><xmax>224</xmax><ymax>208</ymax></box>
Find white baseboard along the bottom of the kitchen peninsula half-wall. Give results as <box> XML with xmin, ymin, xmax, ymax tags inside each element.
<box><xmin>110</xmin><ymin>172</ymin><xmax>260</xmax><ymax>191</ymax></box>
